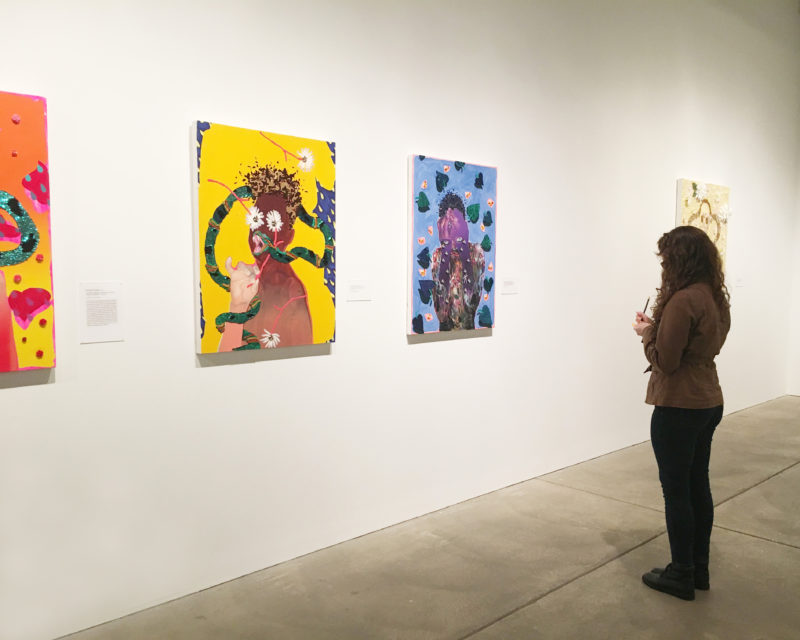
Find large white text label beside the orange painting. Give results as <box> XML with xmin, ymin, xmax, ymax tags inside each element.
<box><xmin>78</xmin><ymin>282</ymin><xmax>125</xmax><ymax>344</ymax></box>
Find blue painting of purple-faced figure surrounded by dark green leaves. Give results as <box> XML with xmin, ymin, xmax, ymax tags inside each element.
<box><xmin>408</xmin><ymin>155</ymin><xmax>497</xmax><ymax>334</ymax></box>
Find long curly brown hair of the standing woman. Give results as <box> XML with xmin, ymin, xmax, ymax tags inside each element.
<box><xmin>653</xmin><ymin>226</ymin><xmax>731</xmax><ymax>328</ymax></box>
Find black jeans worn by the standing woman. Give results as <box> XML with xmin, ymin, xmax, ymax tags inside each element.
<box><xmin>650</xmin><ymin>405</ymin><xmax>722</xmax><ymax>565</ymax></box>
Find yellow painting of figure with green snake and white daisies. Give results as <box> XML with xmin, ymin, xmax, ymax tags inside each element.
<box><xmin>195</xmin><ymin>122</ymin><xmax>336</xmax><ymax>353</ymax></box>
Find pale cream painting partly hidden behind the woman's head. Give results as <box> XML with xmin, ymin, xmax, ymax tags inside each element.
<box><xmin>675</xmin><ymin>178</ymin><xmax>731</xmax><ymax>269</ymax></box>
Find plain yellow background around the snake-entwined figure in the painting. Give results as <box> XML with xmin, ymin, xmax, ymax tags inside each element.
<box><xmin>197</xmin><ymin>123</ymin><xmax>336</xmax><ymax>353</ymax></box>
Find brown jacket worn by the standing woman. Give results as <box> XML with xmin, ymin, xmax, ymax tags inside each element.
<box><xmin>642</xmin><ymin>283</ymin><xmax>731</xmax><ymax>409</ymax></box>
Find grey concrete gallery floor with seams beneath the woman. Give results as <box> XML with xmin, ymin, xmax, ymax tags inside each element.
<box><xmin>68</xmin><ymin>396</ymin><xmax>800</xmax><ymax>640</ymax></box>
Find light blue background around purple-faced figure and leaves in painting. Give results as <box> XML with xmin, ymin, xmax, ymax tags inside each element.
<box><xmin>409</xmin><ymin>156</ymin><xmax>497</xmax><ymax>333</ymax></box>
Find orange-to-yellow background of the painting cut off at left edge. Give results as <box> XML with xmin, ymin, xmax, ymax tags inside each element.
<box><xmin>0</xmin><ymin>92</ymin><xmax>55</xmax><ymax>369</ymax></box>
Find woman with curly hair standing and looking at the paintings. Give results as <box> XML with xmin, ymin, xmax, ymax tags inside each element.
<box><xmin>634</xmin><ymin>226</ymin><xmax>731</xmax><ymax>600</ymax></box>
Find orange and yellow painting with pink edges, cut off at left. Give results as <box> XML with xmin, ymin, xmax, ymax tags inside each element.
<box><xmin>0</xmin><ymin>92</ymin><xmax>56</xmax><ymax>372</ymax></box>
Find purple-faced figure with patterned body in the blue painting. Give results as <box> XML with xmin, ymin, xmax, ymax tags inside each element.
<box><xmin>431</xmin><ymin>193</ymin><xmax>486</xmax><ymax>331</ymax></box>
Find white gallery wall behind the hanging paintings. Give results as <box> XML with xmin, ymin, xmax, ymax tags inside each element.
<box><xmin>0</xmin><ymin>0</ymin><xmax>800</xmax><ymax>640</ymax></box>
